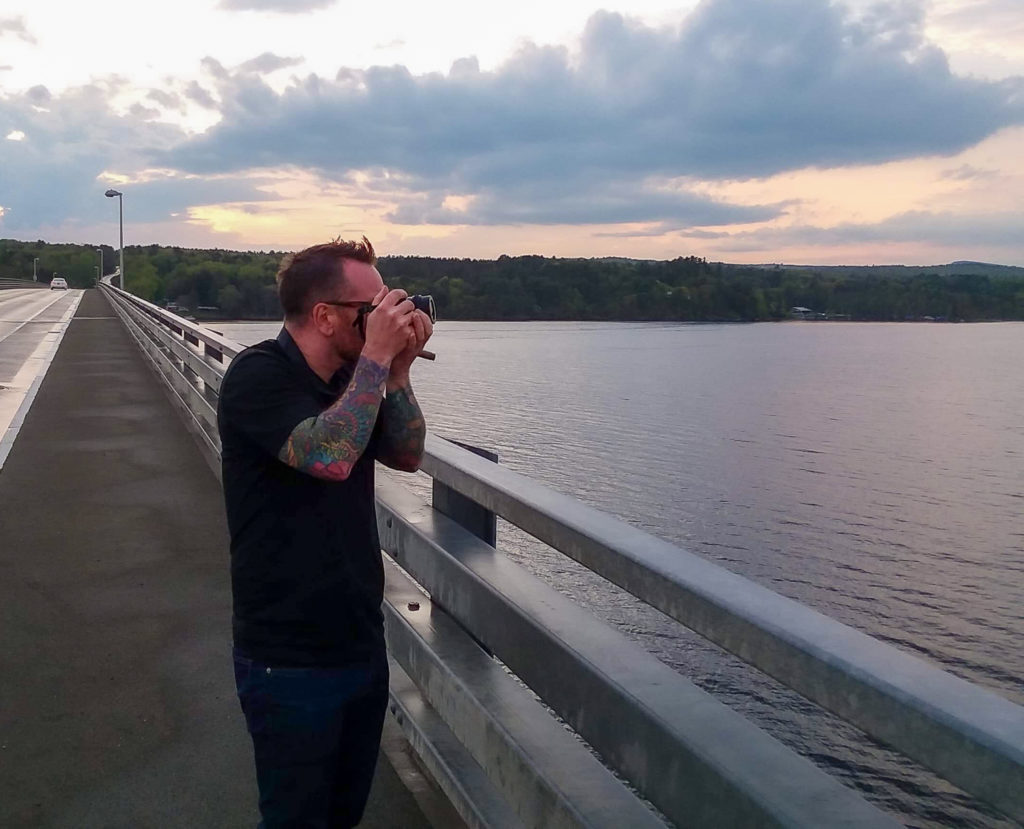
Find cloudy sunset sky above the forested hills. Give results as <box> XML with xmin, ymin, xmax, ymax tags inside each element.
<box><xmin>0</xmin><ymin>0</ymin><xmax>1024</xmax><ymax>265</ymax></box>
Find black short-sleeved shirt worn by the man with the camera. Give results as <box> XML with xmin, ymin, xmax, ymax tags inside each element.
<box><xmin>217</xmin><ymin>330</ymin><xmax>384</xmax><ymax>666</ymax></box>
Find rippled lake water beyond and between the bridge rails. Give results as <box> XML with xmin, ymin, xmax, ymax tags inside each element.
<box><xmin>214</xmin><ymin>321</ymin><xmax>1024</xmax><ymax>827</ymax></box>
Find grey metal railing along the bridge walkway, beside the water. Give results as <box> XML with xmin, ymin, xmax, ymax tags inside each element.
<box><xmin>101</xmin><ymin>283</ymin><xmax>1024</xmax><ymax>829</ymax></box>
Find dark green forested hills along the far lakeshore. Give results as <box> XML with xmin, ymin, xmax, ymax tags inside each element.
<box><xmin>0</xmin><ymin>239</ymin><xmax>1024</xmax><ymax>321</ymax></box>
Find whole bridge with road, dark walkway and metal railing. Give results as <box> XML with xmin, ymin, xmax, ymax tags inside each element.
<box><xmin>0</xmin><ymin>280</ymin><xmax>1024</xmax><ymax>829</ymax></box>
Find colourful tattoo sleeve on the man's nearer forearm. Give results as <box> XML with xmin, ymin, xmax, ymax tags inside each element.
<box><xmin>278</xmin><ymin>357</ymin><xmax>388</xmax><ymax>481</ymax></box>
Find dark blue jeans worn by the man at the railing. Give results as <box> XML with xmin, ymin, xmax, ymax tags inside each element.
<box><xmin>234</xmin><ymin>653</ymin><xmax>388</xmax><ymax>829</ymax></box>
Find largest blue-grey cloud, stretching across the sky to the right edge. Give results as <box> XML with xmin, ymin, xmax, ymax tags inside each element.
<box><xmin>158</xmin><ymin>0</ymin><xmax>1024</xmax><ymax>226</ymax></box>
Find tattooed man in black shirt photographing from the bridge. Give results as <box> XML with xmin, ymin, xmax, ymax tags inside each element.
<box><xmin>218</xmin><ymin>236</ymin><xmax>431</xmax><ymax>829</ymax></box>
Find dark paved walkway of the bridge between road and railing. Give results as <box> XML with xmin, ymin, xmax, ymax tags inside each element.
<box><xmin>0</xmin><ymin>291</ymin><xmax>427</xmax><ymax>829</ymax></box>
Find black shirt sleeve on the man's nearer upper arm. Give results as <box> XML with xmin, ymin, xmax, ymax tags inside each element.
<box><xmin>220</xmin><ymin>351</ymin><xmax>321</xmax><ymax>457</ymax></box>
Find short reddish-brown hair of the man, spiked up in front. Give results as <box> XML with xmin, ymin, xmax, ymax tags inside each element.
<box><xmin>278</xmin><ymin>236</ymin><xmax>377</xmax><ymax>320</ymax></box>
